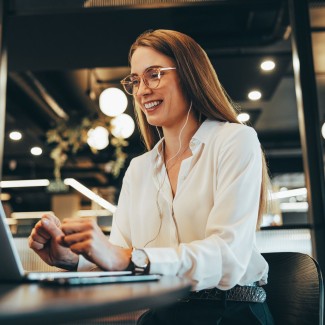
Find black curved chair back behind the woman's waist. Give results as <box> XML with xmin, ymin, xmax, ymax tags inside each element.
<box><xmin>262</xmin><ymin>252</ymin><xmax>324</xmax><ymax>325</ymax></box>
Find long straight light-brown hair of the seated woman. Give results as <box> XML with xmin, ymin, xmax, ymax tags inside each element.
<box><xmin>129</xmin><ymin>29</ymin><xmax>269</xmax><ymax>224</ymax></box>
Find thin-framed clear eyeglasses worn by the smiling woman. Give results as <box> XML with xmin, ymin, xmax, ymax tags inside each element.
<box><xmin>121</xmin><ymin>67</ymin><xmax>176</xmax><ymax>95</ymax></box>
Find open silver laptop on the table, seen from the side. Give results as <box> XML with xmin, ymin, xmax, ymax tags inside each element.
<box><xmin>0</xmin><ymin>202</ymin><xmax>161</xmax><ymax>285</ymax></box>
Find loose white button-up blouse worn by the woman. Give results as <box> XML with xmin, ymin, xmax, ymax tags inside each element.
<box><xmin>80</xmin><ymin>120</ymin><xmax>268</xmax><ymax>290</ymax></box>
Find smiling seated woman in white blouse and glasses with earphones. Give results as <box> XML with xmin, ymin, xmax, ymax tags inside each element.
<box><xmin>30</xmin><ymin>30</ymin><xmax>273</xmax><ymax>324</ymax></box>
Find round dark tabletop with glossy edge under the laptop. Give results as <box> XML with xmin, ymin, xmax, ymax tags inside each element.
<box><xmin>0</xmin><ymin>276</ymin><xmax>191</xmax><ymax>325</ymax></box>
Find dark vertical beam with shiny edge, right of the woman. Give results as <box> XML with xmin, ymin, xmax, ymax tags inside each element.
<box><xmin>289</xmin><ymin>0</ymin><xmax>325</xmax><ymax>273</ymax></box>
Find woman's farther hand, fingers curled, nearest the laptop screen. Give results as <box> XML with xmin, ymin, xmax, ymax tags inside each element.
<box><xmin>28</xmin><ymin>214</ymin><xmax>79</xmax><ymax>270</ymax></box>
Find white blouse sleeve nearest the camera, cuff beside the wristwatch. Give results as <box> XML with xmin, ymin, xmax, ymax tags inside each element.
<box><xmin>145</xmin><ymin>127</ymin><xmax>265</xmax><ymax>290</ymax></box>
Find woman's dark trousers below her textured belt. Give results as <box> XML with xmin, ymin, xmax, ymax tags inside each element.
<box><xmin>137</xmin><ymin>300</ymin><xmax>274</xmax><ymax>325</ymax></box>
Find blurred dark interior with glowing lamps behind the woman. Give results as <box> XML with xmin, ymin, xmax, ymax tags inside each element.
<box><xmin>1</xmin><ymin>0</ymin><xmax>325</xmax><ymax>252</ymax></box>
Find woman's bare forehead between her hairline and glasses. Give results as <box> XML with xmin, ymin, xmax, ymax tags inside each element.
<box><xmin>131</xmin><ymin>46</ymin><xmax>175</xmax><ymax>74</ymax></box>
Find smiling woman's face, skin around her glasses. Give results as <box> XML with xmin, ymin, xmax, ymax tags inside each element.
<box><xmin>131</xmin><ymin>47</ymin><xmax>189</xmax><ymax>128</ymax></box>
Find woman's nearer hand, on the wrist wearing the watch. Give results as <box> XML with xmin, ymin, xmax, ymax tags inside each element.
<box><xmin>61</xmin><ymin>218</ymin><xmax>132</xmax><ymax>271</ymax></box>
